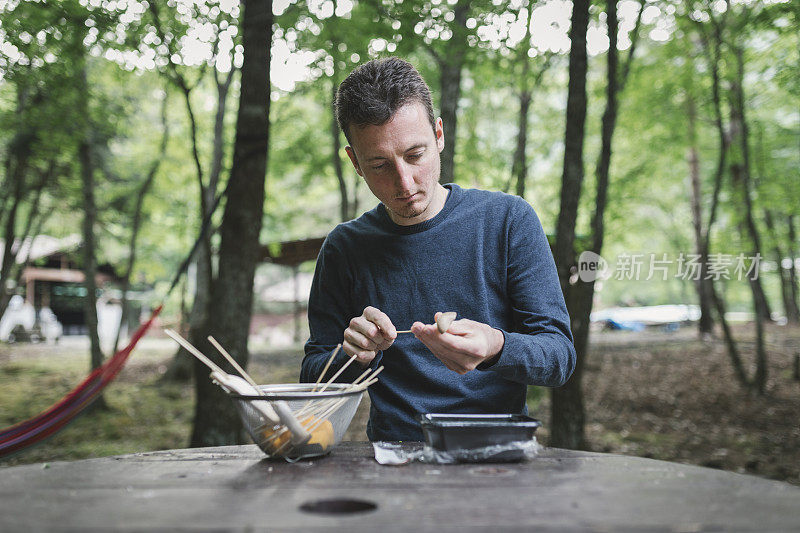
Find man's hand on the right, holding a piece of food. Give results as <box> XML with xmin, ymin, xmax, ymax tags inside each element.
<box><xmin>411</xmin><ymin>313</ymin><xmax>505</xmax><ymax>374</ymax></box>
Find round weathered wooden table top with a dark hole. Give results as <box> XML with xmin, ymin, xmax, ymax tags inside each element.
<box><xmin>0</xmin><ymin>442</ymin><xmax>800</xmax><ymax>532</ymax></box>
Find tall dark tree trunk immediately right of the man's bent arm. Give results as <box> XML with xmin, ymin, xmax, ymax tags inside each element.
<box><xmin>550</xmin><ymin>0</ymin><xmax>589</xmax><ymax>449</ymax></box>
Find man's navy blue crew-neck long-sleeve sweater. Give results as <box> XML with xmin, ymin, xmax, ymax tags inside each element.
<box><xmin>300</xmin><ymin>184</ymin><xmax>575</xmax><ymax>440</ymax></box>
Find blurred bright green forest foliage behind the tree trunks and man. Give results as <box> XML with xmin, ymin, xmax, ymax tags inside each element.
<box><xmin>0</xmin><ymin>0</ymin><xmax>800</xmax><ymax>316</ymax></box>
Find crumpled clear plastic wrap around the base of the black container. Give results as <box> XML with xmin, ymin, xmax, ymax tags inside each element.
<box><xmin>372</xmin><ymin>437</ymin><xmax>542</xmax><ymax>466</ymax></box>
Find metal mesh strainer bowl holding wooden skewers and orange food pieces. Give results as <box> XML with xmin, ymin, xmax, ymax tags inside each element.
<box><xmin>165</xmin><ymin>329</ymin><xmax>383</xmax><ymax>460</ymax></box>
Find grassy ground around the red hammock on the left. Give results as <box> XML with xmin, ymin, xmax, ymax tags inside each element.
<box><xmin>0</xmin><ymin>338</ymin><xmax>194</xmax><ymax>466</ymax></box>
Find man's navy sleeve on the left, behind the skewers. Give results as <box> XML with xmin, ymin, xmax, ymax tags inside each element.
<box><xmin>300</xmin><ymin>233</ymin><xmax>380</xmax><ymax>383</ymax></box>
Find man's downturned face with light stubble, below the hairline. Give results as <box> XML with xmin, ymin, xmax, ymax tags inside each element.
<box><xmin>346</xmin><ymin>102</ymin><xmax>447</xmax><ymax>226</ymax></box>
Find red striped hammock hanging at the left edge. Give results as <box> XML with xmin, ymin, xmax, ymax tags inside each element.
<box><xmin>0</xmin><ymin>306</ymin><xmax>161</xmax><ymax>457</ymax></box>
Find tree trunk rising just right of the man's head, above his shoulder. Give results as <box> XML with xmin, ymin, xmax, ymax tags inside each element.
<box><xmin>439</xmin><ymin>0</ymin><xmax>472</xmax><ymax>183</ymax></box>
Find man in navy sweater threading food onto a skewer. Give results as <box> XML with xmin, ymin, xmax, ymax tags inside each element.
<box><xmin>301</xmin><ymin>58</ymin><xmax>575</xmax><ymax>440</ymax></box>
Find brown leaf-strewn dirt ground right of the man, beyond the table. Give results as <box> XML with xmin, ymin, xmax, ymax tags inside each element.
<box><xmin>560</xmin><ymin>326</ymin><xmax>800</xmax><ymax>485</ymax></box>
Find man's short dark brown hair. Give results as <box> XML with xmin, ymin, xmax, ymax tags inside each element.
<box><xmin>335</xmin><ymin>57</ymin><xmax>436</xmax><ymax>142</ymax></box>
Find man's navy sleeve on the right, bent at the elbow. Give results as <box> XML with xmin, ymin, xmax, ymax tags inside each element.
<box><xmin>478</xmin><ymin>196</ymin><xmax>576</xmax><ymax>387</ymax></box>
